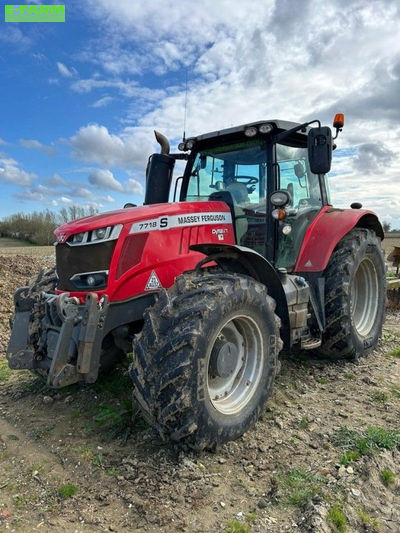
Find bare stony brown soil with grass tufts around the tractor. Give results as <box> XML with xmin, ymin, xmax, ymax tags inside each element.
<box><xmin>0</xmin><ymin>248</ymin><xmax>400</xmax><ymax>533</ymax></box>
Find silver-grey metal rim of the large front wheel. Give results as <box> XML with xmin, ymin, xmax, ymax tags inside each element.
<box><xmin>207</xmin><ymin>315</ymin><xmax>264</xmax><ymax>415</ymax></box>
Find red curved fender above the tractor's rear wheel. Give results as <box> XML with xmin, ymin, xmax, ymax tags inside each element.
<box><xmin>293</xmin><ymin>206</ymin><xmax>380</xmax><ymax>272</ymax></box>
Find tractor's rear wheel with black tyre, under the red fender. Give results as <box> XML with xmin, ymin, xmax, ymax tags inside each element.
<box><xmin>317</xmin><ymin>228</ymin><xmax>386</xmax><ymax>360</ymax></box>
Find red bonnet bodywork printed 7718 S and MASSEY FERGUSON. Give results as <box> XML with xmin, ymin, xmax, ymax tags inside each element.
<box><xmin>55</xmin><ymin>202</ymin><xmax>235</xmax><ymax>302</ymax></box>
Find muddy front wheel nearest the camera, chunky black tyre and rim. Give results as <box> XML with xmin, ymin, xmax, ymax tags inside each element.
<box><xmin>130</xmin><ymin>271</ymin><xmax>282</xmax><ymax>450</ymax></box>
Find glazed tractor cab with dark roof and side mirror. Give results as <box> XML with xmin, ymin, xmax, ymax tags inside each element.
<box><xmin>147</xmin><ymin>120</ymin><xmax>332</xmax><ymax>271</ymax></box>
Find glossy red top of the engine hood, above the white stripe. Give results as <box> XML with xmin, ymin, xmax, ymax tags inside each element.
<box><xmin>54</xmin><ymin>202</ymin><xmax>230</xmax><ymax>243</ymax></box>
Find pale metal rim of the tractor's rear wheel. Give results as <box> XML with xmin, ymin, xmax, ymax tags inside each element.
<box><xmin>350</xmin><ymin>257</ymin><xmax>379</xmax><ymax>336</ymax></box>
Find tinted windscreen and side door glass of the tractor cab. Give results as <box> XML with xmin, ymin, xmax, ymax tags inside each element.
<box><xmin>181</xmin><ymin>138</ymin><xmax>322</xmax><ymax>269</ymax></box>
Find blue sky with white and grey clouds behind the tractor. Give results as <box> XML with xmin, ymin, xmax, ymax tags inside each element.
<box><xmin>0</xmin><ymin>0</ymin><xmax>400</xmax><ymax>229</ymax></box>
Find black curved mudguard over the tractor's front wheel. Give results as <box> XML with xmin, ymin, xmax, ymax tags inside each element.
<box><xmin>190</xmin><ymin>244</ymin><xmax>290</xmax><ymax>348</ymax></box>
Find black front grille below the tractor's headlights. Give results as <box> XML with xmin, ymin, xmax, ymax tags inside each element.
<box><xmin>56</xmin><ymin>240</ymin><xmax>117</xmax><ymax>292</ymax></box>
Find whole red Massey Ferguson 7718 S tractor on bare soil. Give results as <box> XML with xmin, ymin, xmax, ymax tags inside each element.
<box><xmin>7</xmin><ymin>115</ymin><xmax>386</xmax><ymax>449</ymax></box>
